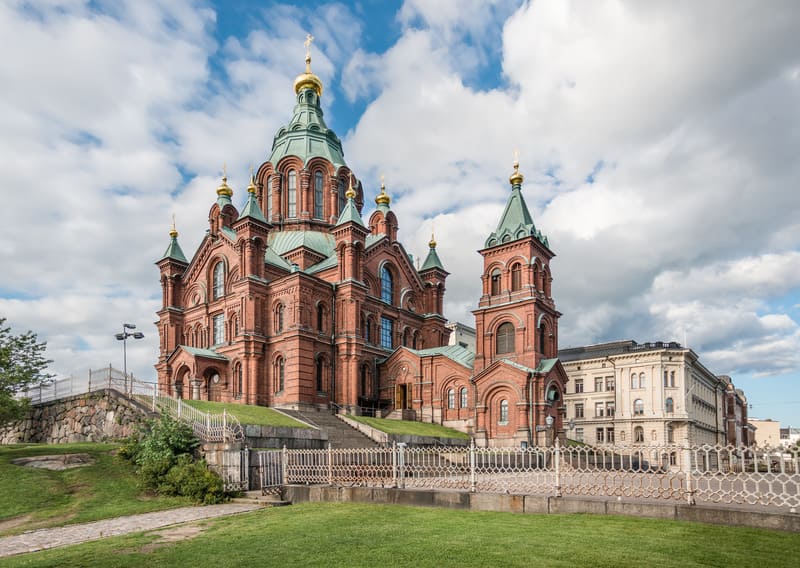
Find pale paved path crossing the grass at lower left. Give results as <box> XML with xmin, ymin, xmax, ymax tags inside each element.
<box><xmin>0</xmin><ymin>503</ymin><xmax>261</xmax><ymax>558</ymax></box>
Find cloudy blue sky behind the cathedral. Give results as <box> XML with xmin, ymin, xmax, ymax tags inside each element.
<box><xmin>0</xmin><ymin>0</ymin><xmax>800</xmax><ymax>426</ymax></box>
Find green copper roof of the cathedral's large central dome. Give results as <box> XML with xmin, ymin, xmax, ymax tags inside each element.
<box><xmin>269</xmin><ymin>89</ymin><xmax>345</xmax><ymax>169</ymax></box>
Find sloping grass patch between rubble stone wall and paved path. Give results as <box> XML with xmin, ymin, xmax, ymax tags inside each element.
<box><xmin>0</xmin><ymin>444</ymin><xmax>191</xmax><ymax>535</ymax></box>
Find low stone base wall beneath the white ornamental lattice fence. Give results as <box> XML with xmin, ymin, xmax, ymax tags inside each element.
<box><xmin>283</xmin><ymin>485</ymin><xmax>800</xmax><ymax>532</ymax></box>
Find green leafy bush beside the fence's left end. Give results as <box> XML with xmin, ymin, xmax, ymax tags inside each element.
<box><xmin>119</xmin><ymin>415</ymin><xmax>225</xmax><ymax>504</ymax></box>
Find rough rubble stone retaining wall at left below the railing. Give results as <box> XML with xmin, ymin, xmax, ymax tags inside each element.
<box><xmin>0</xmin><ymin>390</ymin><xmax>154</xmax><ymax>444</ymax></box>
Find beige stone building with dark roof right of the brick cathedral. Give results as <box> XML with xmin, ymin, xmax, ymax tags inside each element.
<box><xmin>558</xmin><ymin>341</ymin><xmax>730</xmax><ymax>446</ymax></box>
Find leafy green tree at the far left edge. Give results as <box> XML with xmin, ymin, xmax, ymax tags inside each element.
<box><xmin>0</xmin><ymin>318</ymin><xmax>53</xmax><ymax>424</ymax></box>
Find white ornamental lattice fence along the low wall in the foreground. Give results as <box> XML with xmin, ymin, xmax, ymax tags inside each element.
<box><xmin>259</xmin><ymin>443</ymin><xmax>800</xmax><ymax>511</ymax></box>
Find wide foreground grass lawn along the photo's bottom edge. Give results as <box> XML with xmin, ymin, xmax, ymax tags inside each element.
<box><xmin>0</xmin><ymin>503</ymin><xmax>800</xmax><ymax>568</ymax></box>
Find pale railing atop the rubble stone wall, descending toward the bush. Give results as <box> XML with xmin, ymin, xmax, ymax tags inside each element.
<box><xmin>18</xmin><ymin>365</ymin><xmax>244</xmax><ymax>442</ymax></box>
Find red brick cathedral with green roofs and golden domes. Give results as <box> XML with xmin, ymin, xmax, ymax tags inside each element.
<box><xmin>156</xmin><ymin>46</ymin><xmax>566</xmax><ymax>446</ymax></box>
